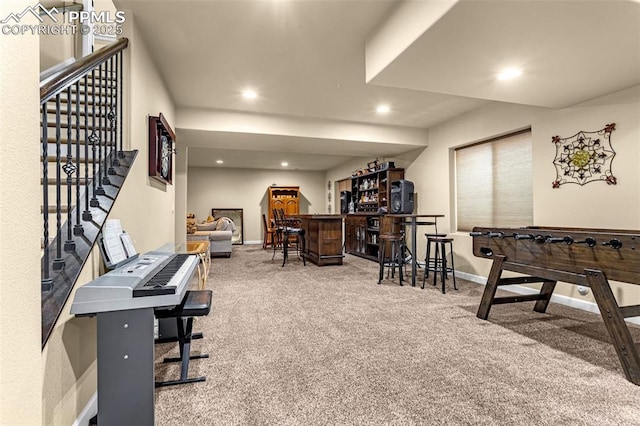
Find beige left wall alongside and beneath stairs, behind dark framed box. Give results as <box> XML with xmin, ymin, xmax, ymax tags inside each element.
<box><xmin>41</xmin><ymin>11</ymin><xmax>175</xmax><ymax>425</ymax></box>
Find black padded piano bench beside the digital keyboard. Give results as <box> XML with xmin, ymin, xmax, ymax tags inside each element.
<box><xmin>156</xmin><ymin>290</ymin><xmax>212</xmax><ymax>388</ymax></box>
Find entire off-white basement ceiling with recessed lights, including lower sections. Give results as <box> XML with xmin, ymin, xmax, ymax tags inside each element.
<box><xmin>114</xmin><ymin>0</ymin><xmax>640</xmax><ymax>170</ymax></box>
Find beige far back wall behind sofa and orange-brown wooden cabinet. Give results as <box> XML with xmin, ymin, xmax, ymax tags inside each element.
<box><xmin>183</xmin><ymin>167</ymin><xmax>327</xmax><ymax>242</ymax></box>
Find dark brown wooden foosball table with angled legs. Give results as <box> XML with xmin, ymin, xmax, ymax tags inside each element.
<box><xmin>470</xmin><ymin>227</ymin><xmax>640</xmax><ymax>385</ymax></box>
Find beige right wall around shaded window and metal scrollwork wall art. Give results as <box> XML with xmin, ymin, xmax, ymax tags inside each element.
<box><xmin>406</xmin><ymin>86</ymin><xmax>640</xmax><ymax>304</ymax></box>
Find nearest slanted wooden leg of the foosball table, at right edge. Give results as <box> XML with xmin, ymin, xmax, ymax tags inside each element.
<box><xmin>585</xmin><ymin>269</ymin><xmax>640</xmax><ymax>385</ymax></box>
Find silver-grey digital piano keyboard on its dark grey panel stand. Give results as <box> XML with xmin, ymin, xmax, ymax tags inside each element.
<box><xmin>70</xmin><ymin>250</ymin><xmax>198</xmax><ymax>426</ymax></box>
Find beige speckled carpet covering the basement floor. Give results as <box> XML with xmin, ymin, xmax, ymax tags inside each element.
<box><xmin>155</xmin><ymin>246</ymin><xmax>640</xmax><ymax>426</ymax></box>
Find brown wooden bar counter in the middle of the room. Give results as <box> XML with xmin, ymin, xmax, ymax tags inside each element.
<box><xmin>295</xmin><ymin>214</ymin><xmax>344</xmax><ymax>266</ymax></box>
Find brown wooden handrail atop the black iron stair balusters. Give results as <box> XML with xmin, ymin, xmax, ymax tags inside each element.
<box><xmin>40</xmin><ymin>38</ymin><xmax>129</xmax><ymax>104</ymax></box>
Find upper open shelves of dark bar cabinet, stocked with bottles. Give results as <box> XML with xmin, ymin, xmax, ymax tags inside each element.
<box><xmin>351</xmin><ymin>168</ymin><xmax>404</xmax><ymax>214</ymax></box>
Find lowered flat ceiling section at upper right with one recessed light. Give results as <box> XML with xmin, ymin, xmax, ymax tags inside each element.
<box><xmin>372</xmin><ymin>0</ymin><xmax>640</xmax><ymax>108</ymax></box>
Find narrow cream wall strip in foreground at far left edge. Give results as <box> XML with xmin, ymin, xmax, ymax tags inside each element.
<box><xmin>0</xmin><ymin>0</ymin><xmax>42</xmax><ymax>425</ymax></box>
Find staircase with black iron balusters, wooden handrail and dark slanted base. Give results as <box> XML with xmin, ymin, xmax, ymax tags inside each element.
<box><xmin>40</xmin><ymin>39</ymin><xmax>137</xmax><ymax>348</ymax></box>
